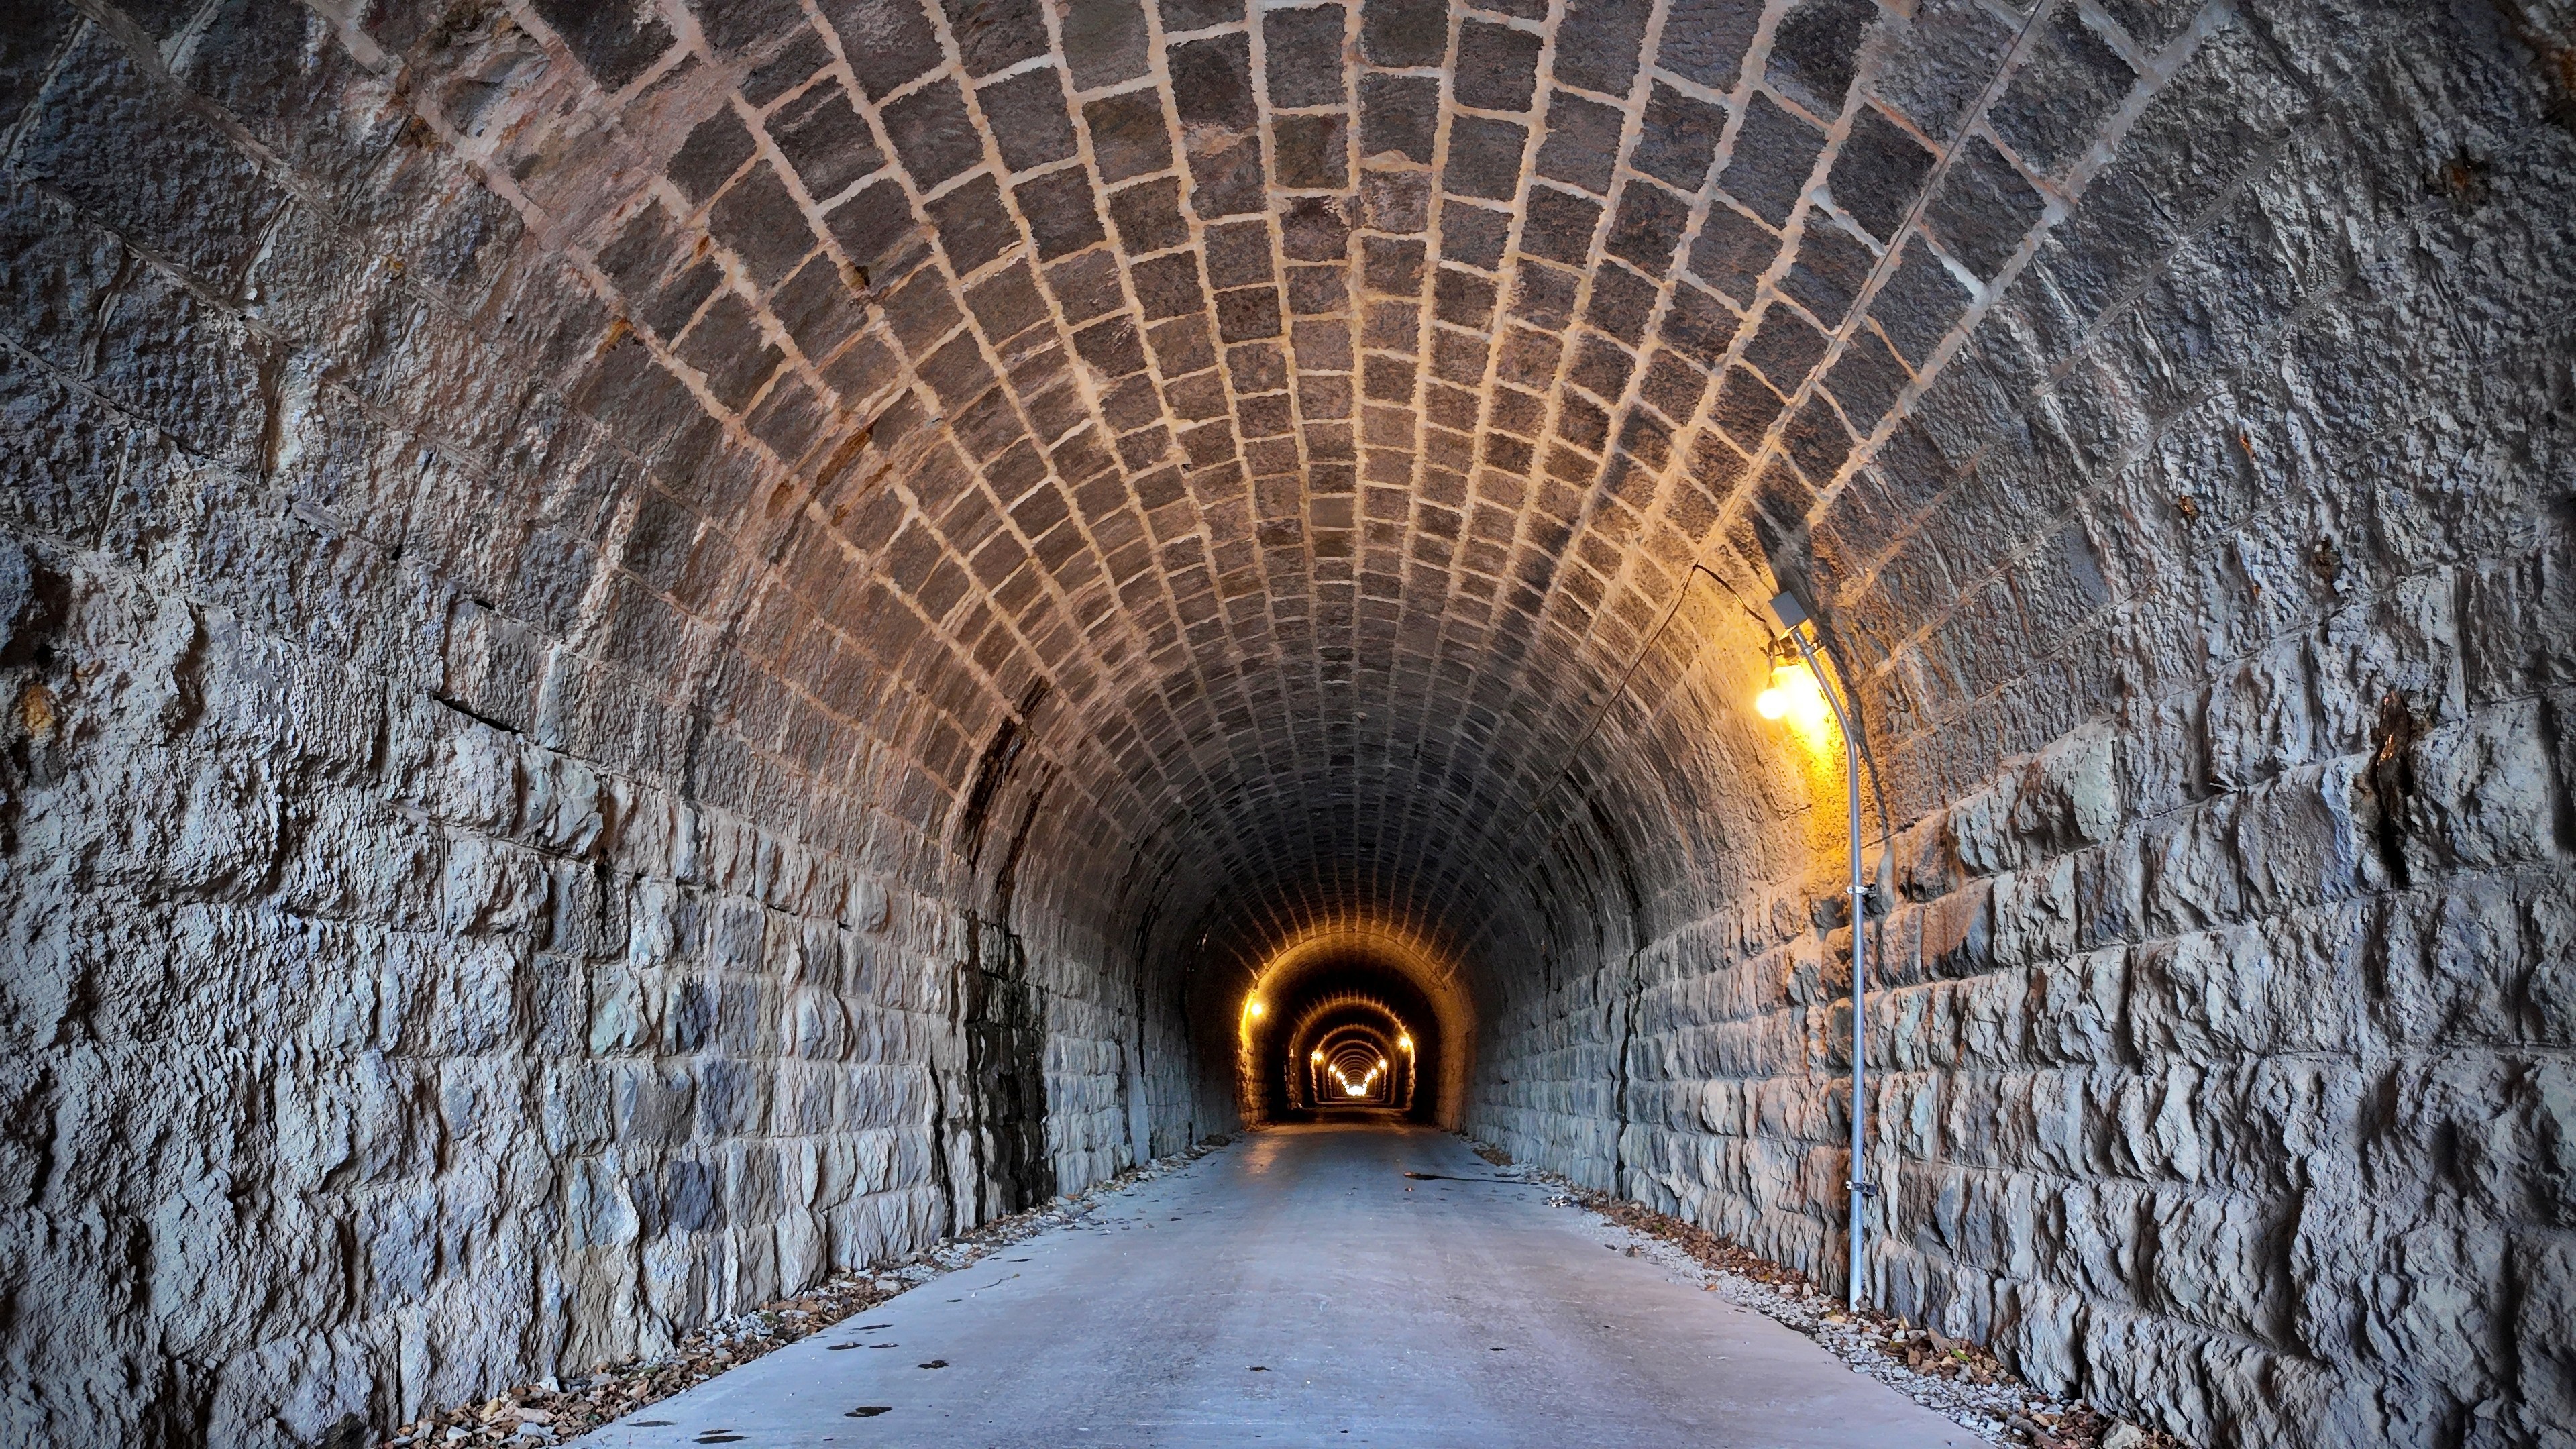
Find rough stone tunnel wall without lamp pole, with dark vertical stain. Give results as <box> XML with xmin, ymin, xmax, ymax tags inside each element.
<box><xmin>0</xmin><ymin>3</ymin><xmax>1195</xmax><ymax>1446</ymax></box>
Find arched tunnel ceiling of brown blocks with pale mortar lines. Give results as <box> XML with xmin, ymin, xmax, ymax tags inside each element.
<box><xmin>374</xmin><ymin>0</ymin><xmax>2493</xmax><ymax>989</ymax></box>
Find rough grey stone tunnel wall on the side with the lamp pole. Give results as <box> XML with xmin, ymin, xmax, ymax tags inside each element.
<box><xmin>1476</xmin><ymin>3</ymin><xmax>2576</xmax><ymax>1444</ymax></box>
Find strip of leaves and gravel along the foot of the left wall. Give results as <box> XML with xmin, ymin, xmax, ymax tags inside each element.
<box><xmin>378</xmin><ymin>1137</ymin><xmax>1229</xmax><ymax>1449</ymax></box>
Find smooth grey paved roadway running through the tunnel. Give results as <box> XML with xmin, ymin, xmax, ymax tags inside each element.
<box><xmin>582</xmin><ymin>1119</ymin><xmax>1976</xmax><ymax>1449</ymax></box>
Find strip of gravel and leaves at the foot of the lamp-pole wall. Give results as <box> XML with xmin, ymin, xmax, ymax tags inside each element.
<box><xmin>1471</xmin><ymin>1142</ymin><xmax>2184</xmax><ymax>1449</ymax></box>
